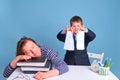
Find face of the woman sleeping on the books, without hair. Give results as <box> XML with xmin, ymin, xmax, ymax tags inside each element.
<box><xmin>22</xmin><ymin>40</ymin><xmax>41</xmax><ymax>57</ymax></box>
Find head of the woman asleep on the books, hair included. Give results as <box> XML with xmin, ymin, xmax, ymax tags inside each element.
<box><xmin>16</xmin><ymin>37</ymin><xmax>41</xmax><ymax>57</ymax></box>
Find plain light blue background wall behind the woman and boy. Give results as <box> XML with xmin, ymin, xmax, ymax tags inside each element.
<box><xmin>0</xmin><ymin>0</ymin><xmax>120</xmax><ymax>80</ymax></box>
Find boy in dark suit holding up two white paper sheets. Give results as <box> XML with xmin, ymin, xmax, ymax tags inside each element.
<box><xmin>57</xmin><ymin>16</ymin><xmax>96</xmax><ymax>65</ymax></box>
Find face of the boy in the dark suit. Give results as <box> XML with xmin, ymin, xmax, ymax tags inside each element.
<box><xmin>71</xmin><ymin>22</ymin><xmax>83</xmax><ymax>34</ymax></box>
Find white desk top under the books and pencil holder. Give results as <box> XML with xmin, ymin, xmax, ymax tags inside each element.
<box><xmin>7</xmin><ymin>66</ymin><xmax>119</xmax><ymax>80</ymax></box>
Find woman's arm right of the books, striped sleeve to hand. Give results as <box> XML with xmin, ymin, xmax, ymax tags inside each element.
<box><xmin>34</xmin><ymin>46</ymin><xmax>68</xmax><ymax>80</ymax></box>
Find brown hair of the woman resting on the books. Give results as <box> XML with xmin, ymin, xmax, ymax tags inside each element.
<box><xmin>16</xmin><ymin>36</ymin><xmax>38</xmax><ymax>56</ymax></box>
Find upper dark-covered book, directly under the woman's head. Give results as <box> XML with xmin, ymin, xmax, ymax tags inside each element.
<box><xmin>17</xmin><ymin>57</ymin><xmax>47</xmax><ymax>66</ymax></box>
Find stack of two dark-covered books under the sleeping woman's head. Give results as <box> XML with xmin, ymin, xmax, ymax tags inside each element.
<box><xmin>17</xmin><ymin>57</ymin><xmax>52</xmax><ymax>71</ymax></box>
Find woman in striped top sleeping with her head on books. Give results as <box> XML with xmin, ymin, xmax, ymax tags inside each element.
<box><xmin>3</xmin><ymin>37</ymin><xmax>68</xmax><ymax>80</ymax></box>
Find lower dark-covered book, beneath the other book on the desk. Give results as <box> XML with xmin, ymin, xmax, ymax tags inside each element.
<box><xmin>21</xmin><ymin>60</ymin><xmax>52</xmax><ymax>71</ymax></box>
